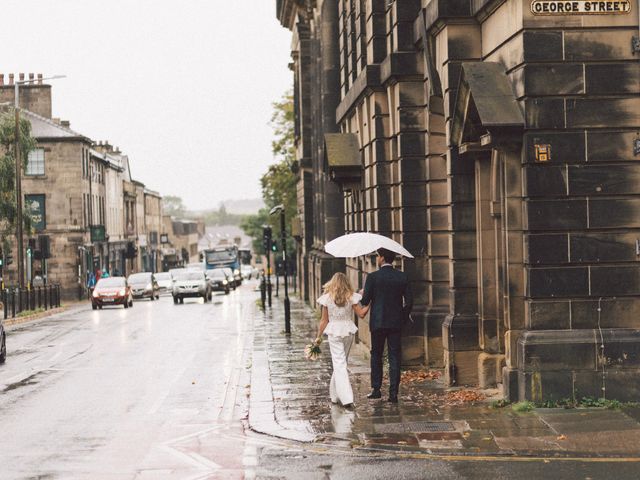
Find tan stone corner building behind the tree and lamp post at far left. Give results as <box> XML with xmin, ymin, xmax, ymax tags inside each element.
<box><xmin>14</xmin><ymin>110</ymin><xmax>93</xmax><ymax>298</ymax></box>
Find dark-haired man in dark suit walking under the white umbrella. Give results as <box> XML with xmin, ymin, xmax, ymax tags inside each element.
<box><xmin>360</xmin><ymin>248</ymin><xmax>413</xmax><ymax>403</ymax></box>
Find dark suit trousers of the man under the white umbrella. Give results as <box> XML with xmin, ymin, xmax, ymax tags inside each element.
<box><xmin>371</xmin><ymin>328</ymin><xmax>402</xmax><ymax>396</ymax></box>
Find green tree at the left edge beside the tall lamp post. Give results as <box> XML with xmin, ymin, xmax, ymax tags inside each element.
<box><xmin>0</xmin><ymin>112</ymin><xmax>37</xmax><ymax>251</ymax></box>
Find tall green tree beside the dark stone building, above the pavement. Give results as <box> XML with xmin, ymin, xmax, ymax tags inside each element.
<box><xmin>240</xmin><ymin>91</ymin><xmax>298</xmax><ymax>254</ymax></box>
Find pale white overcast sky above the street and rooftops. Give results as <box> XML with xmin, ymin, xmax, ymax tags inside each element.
<box><xmin>0</xmin><ymin>0</ymin><xmax>292</xmax><ymax>209</ymax></box>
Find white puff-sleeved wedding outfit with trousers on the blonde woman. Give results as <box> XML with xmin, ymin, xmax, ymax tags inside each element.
<box><xmin>317</xmin><ymin>293</ymin><xmax>362</xmax><ymax>405</ymax></box>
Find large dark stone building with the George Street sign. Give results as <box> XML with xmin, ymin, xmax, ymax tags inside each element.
<box><xmin>277</xmin><ymin>0</ymin><xmax>640</xmax><ymax>401</ymax></box>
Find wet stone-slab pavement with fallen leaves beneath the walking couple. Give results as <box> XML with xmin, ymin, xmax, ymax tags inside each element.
<box><xmin>249</xmin><ymin>294</ymin><xmax>640</xmax><ymax>460</ymax></box>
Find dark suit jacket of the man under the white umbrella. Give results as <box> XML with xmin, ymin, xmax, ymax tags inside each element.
<box><xmin>360</xmin><ymin>266</ymin><xmax>413</xmax><ymax>330</ymax></box>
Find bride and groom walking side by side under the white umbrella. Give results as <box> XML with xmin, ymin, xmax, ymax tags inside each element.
<box><xmin>317</xmin><ymin>248</ymin><xmax>413</xmax><ymax>408</ymax></box>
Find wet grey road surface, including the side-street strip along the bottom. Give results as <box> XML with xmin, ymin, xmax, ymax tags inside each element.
<box><xmin>0</xmin><ymin>284</ymin><xmax>640</xmax><ymax>480</ymax></box>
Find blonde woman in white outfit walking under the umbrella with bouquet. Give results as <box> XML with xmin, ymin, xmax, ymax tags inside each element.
<box><xmin>317</xmin><ymin>273</ymin><xmax>369</xmax><ymax>408</ymax></box>
